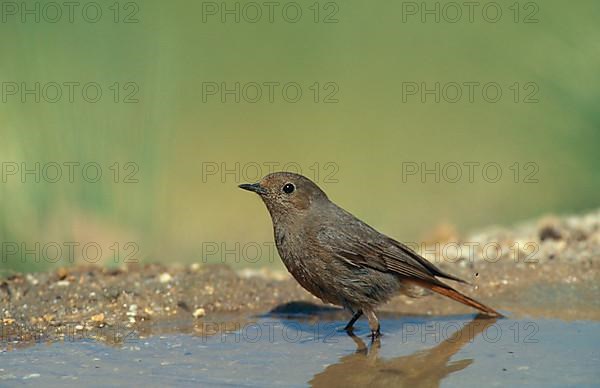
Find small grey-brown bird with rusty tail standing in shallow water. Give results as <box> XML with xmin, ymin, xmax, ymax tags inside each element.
<box><xmin>239</xmin><ymin>172</ymin><xmax>501</xmax><ymax>338</ymax></box>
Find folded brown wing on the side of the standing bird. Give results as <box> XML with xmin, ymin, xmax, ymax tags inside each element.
<box><xmin>317</xmin><ymin>217</ymin><xmax>465</xmax><ymax>283</ymax></box>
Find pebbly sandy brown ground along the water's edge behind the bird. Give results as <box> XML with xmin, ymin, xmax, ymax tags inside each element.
<box><xmin>0</xmin><ymin>211</ymin><xmax>600</xmax><ymax>343</ymax></box>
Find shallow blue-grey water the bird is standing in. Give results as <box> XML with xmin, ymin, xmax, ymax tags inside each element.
<box><xmin>0</xmin><ymin>310</ymin><xmax>600</xmax><ymax>387</ymax></box>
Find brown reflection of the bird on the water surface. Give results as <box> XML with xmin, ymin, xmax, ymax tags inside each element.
<box><xmin>309</xmin><ymin>316</ymin><xmax>496</xmax><ymax>387</ymax></box>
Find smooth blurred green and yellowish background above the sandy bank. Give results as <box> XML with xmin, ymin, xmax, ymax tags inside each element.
<box><xmin>0</xmin><ymin>0</ymin><xmax>600</xmax><ymax>271</ymax></box>
